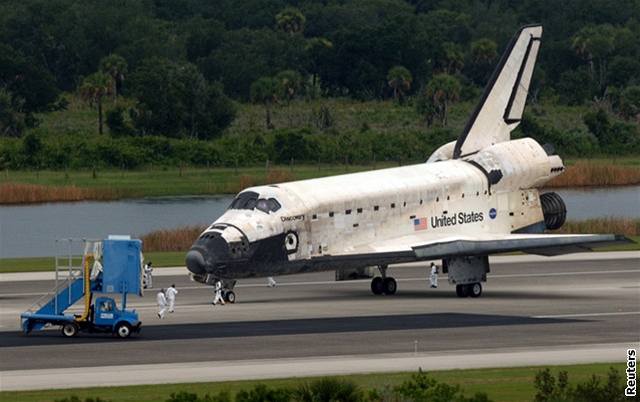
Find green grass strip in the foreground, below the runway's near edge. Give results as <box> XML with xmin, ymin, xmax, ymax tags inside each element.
<box><xmin>0</xmin><ymin>363</ymin><xmax>624</xmax><ymax>402</ymax></box>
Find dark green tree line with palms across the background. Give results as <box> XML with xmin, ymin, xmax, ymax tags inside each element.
<box><xmin>0</xmin><ymin>0</ymin><xmax>640</xmax><ymax>163</ymax></box>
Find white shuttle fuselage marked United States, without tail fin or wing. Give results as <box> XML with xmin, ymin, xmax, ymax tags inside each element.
<box><xmin>188</xmin><ymin>139</ymin><xmax>561</xmax><ymax>277</ymax></box>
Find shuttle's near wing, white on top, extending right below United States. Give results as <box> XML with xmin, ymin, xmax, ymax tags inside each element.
<box><xmin>313</xmin><ymin>234</ymin><xmax>631</xmax><ymax>265</ymax></box>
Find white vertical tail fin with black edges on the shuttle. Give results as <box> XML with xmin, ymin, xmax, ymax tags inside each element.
<box><xmin>453</xmin><ymin>25</ymin><xmax>542</xmax><ymax>159</ymax></box>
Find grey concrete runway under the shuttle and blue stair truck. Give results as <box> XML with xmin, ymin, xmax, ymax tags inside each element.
<box><xmin>0</xmin><ymin>252</ymin><xmax>640</xmax><ymax>390</ymax></box>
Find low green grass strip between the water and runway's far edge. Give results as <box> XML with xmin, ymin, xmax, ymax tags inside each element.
<box><xmin>0</xmin><ymin>236</ymin><xmax>640</xmax><ymax>274</ymax></box>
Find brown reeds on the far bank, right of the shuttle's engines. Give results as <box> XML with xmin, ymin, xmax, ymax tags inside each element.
<box><xmin>546</xmin><ymin>162</ymin><xmax>640</xmax><ymax>187</ymax></box>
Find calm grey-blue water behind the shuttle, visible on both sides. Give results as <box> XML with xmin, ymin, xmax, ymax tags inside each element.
<box><xmin>0</xmin><ymin>186</ymin><xmax>640</xmax><ymax>258</ymax></box>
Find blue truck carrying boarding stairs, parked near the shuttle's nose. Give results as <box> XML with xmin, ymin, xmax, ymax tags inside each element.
<box><xmin>20</xmin><ymin>236</ymin><xmax>143</xmax><ymax>338</ymax></box>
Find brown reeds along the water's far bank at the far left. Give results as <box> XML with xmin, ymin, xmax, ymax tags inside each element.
<box><xmin>0</xmin><ymin>182</ymin><xmax>119</xmax><ymax>204</ymax></box>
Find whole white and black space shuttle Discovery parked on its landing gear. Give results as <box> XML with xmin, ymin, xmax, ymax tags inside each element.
<box><xmin>186</xmin><ymin>25</ymin><xmax>627</xmax><ymax>297</ymax></box>
